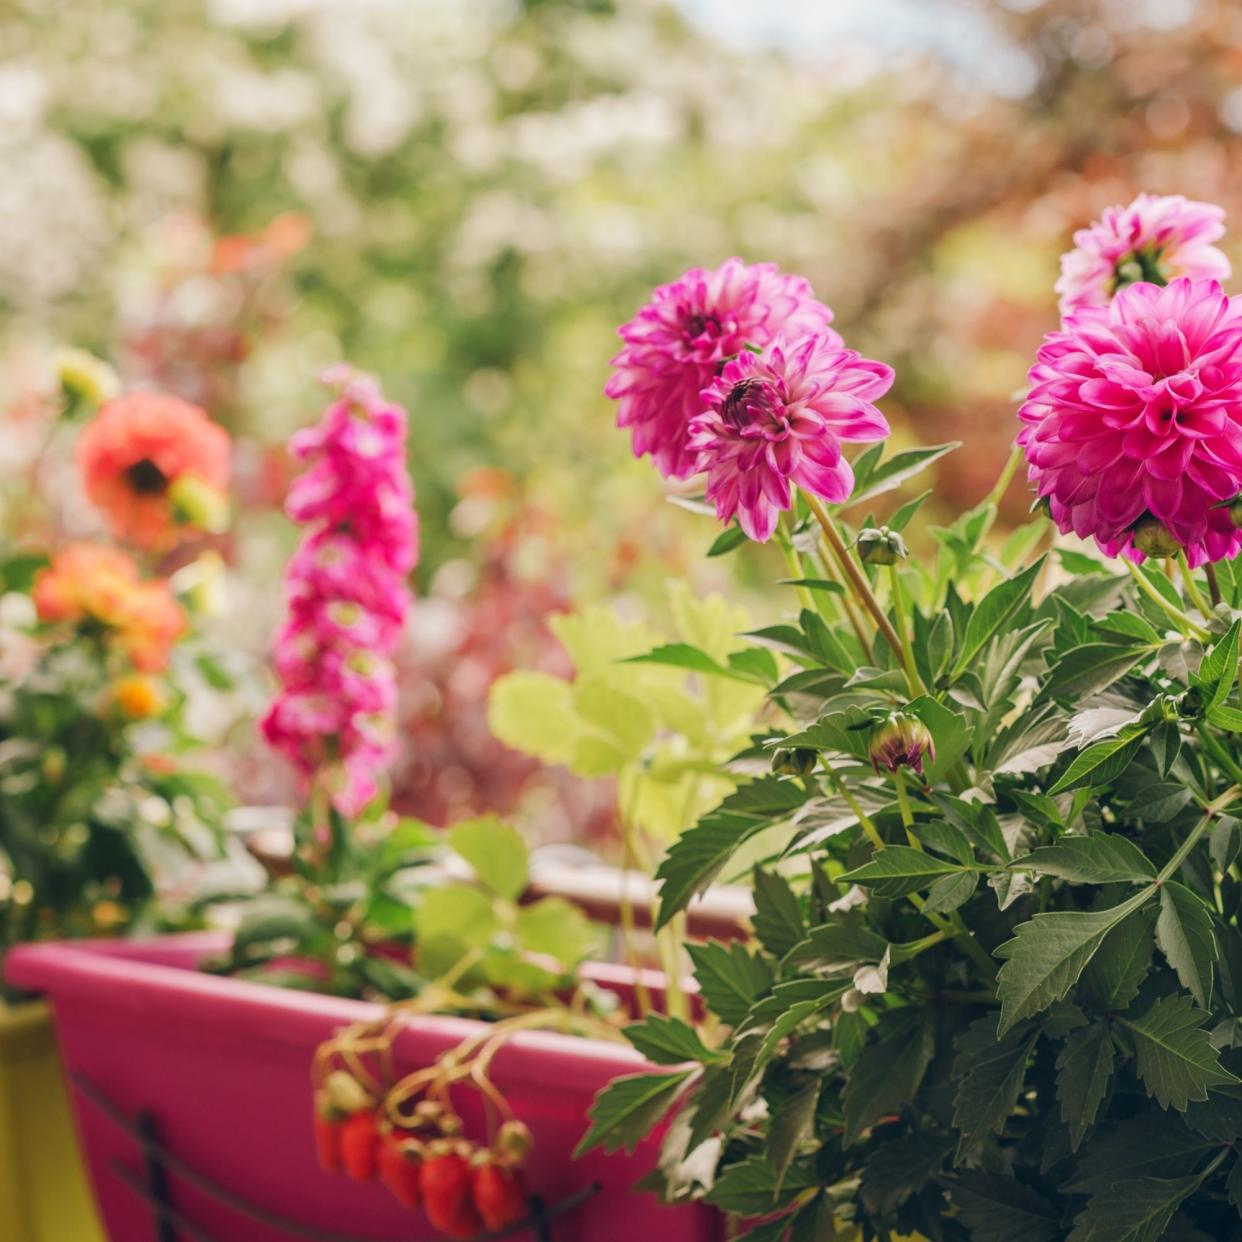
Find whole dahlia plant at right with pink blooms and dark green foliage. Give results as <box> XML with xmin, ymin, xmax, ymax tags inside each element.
<box><xmin>582</xmin><ymin>196</ymin><xmax>1242</xmax><ymax>1242</ymax></box>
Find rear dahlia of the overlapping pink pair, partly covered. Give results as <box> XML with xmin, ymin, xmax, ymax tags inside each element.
<box><xmin>604</xmin><ymin>258</ymin><xmax>841</xmax><ymax>478</ymax></box>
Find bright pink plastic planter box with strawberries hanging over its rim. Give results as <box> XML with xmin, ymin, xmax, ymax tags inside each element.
<box><xmin>6</xmin><ymin>934</ymin><xmax>724</xmax><ymax>1242</ymax></box>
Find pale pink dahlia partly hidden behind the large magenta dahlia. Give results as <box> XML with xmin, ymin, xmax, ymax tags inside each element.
<box><xmin>1057</xmin><ymin>194</ymin><xmax>1230</xmax><ymax>315</ymax></box>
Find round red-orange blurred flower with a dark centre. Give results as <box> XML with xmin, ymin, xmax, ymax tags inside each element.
<box><xmin>77</xmin><ymin>391</ymin><xmax>229</xmax><ymax>548</ymax></box>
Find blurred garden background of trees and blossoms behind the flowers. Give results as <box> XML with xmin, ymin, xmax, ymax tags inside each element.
<box><xmin>0</xmin><ymin>0</ymin><xmax>1242</xmax><ymax>836</ymax></box>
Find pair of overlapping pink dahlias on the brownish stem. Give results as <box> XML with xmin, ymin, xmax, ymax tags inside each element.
<box><xmin>605</xmin><ymin>258</ymin><xmax>893</xmax><ymax>540</ymax></box>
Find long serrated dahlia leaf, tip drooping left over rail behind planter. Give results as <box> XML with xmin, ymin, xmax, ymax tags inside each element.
<box><xmin>656</xmin><ymin>776</ymin><xmax>809</xmax><ymax>930</ymax></box>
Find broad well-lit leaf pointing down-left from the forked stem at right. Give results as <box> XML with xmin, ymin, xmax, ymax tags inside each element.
<box><xmin>996</xmin><ymin>889</ymin><xmax>1151</xmax><ymax>1035</ymax></box>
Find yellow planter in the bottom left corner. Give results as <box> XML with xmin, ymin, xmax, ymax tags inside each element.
<box><xmin>0</xmin><ymin>1002</ymin><xmax>104</xmax><ymax>1242</ymax></box>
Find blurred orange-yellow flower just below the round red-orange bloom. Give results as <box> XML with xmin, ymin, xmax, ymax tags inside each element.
<box><xmin>34</xmin><ymin>544</ymin><xmax>186</xmax><ymax>673</ymax></box>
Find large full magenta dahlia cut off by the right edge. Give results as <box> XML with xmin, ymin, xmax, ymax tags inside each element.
<box><xmin>1017</xmin><ymin>278</ymin><xmax>1242</xmax><ymax>565</ymax></box>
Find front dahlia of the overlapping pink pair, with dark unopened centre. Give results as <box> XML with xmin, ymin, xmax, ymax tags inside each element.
<box><xmin>689</xmin><ymin>332</ymin><xmax>893</xmax><ymax>542</ymax></box>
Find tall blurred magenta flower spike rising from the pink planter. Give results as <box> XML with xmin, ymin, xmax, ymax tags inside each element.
<box><xmin>262</xmin><ymin>368</ymin><xmax>419</xmax><ymax>815</ymax></box>
